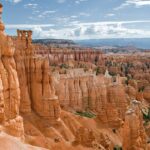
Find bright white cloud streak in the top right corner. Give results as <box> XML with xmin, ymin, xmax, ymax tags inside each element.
<box><xmin>114</xmin><ymin>0</ymin><xmax>150</xmax><ymax>10</ymax></box>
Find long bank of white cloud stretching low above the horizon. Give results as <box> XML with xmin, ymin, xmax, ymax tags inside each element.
<box><xmin>6</xmin><ymin>20</ymin><xmax>150</xmax><ymax>39</ymax></box>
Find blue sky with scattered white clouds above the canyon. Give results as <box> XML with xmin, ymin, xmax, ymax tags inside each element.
<box><xmin>0</xmin><ymin>0</ymin><xmax>150</xmax><ymax>40</ymax></box>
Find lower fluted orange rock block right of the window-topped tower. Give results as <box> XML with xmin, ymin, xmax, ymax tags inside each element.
<box><xmin>31</xmin><ymin>58</ymin><xmax>60</xmax><ymax>121</ymax></box>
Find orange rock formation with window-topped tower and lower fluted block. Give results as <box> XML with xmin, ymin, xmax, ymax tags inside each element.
<box><xmin>14</xmin><ymin>31</ymin><xmax>60</xmax><ymax>121</ymax></box>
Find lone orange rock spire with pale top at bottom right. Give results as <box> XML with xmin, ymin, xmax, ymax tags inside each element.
<box><xmin>121</xmin><ymin>100</ymin><xmax>146</xmax><ymax>150</ymax></box>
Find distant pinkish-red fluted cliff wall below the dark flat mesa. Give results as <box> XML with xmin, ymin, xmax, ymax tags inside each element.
<box><xmin>34</xmin><ymin>44</ymin><xmax>103</xmax><ymax>65</ymax></box>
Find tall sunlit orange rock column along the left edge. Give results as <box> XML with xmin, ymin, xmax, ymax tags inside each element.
<box><xmin>0</xmin><ymin>27</ymin><xmax>24</xmax><ymax>138</ymax></box>
